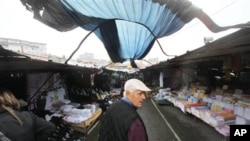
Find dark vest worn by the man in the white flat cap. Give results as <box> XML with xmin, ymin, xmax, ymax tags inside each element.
<box><xmin>99</xmin><ymin>100</ymin><xmax>147</xmax><ymax>141</ymax></box>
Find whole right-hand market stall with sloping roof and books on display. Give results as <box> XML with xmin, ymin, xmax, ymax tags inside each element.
<box><xmin>143</xmin><ymin>29</ymin><xmax>250</xmax><ymax>137</ymax></box>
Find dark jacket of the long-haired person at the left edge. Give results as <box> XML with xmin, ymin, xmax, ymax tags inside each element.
<box><xmin>0</xmin><ymin>111</ymin><xmax>56</xmax><ymax>141</ymax></box>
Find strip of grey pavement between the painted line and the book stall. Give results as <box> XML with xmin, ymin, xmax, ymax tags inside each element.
<box><xmin>154</xmin><ymin>99</ymin><xmax>226</xmax><ymax>141</ymax></box>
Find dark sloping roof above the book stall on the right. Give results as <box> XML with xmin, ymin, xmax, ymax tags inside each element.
<box><xmin>146</xmin><ymin>28</ymin><xmax>250</xmax><ymax>69</ymax></box>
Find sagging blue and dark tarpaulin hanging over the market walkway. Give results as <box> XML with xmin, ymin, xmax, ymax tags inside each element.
<box><xmin>21</xmin><ymin>0</ymin><xmax>249</xmax><ymax>66</ymax></box>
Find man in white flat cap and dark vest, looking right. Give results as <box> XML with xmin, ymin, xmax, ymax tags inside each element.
<box><xmin>99</xmin><ymin>79</ymin><xmax>151</xmax><ymax>141</ymax></box>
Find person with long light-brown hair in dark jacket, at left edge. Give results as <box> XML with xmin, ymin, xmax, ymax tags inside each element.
<box><xmin>0</xmin><ymin>88</ymin><xmax>56</xmax><ymax>141</ymax></box>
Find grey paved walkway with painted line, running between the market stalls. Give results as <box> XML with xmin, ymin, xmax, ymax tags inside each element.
<box><xmin>87</xmin><ymin>99</ymin><xmax>226</xmax><ymax>141</ymax></box>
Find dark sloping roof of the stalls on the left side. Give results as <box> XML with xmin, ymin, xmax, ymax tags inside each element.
<box><xmin>0</xmin><ymin>45</ymin><xmax>96</xmax><ymax>72</ymax></box>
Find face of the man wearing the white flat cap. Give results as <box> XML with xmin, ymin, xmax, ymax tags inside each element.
<box><xmin>127</xmin><ymin>90</ymin><xmax>146</xmax><ymax>108</ymax></box>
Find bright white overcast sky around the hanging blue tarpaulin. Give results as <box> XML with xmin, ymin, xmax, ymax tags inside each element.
<box><xmin>0</xmin><ymin>0</ymin><xmax>250</xmax><ymax>61</ymax></box>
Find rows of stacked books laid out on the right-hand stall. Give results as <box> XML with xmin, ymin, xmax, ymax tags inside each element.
<box><xmin>165</xmin><ymin>87</ymin><xmax>250</xmax><ymax>136</ymax></box>
